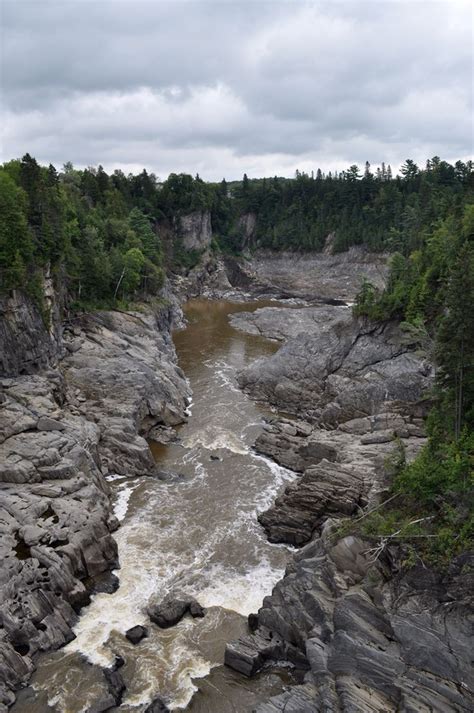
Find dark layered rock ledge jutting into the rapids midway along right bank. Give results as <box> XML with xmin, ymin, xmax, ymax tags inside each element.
<box><xmin>255</xmin><ymin>413</ymin><xmax>426</xmax><ymax>546</ymax></box>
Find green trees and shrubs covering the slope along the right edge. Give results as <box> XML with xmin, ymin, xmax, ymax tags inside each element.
<box><xmin>348</xmin><ymin>203</ymin><xmax>474</xmax><ymax>567</ymax></box>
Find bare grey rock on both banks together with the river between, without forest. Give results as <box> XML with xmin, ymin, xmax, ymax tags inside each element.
<box><xmin>1</xmin><ymin>250</ymin><xmax>471</xmax><ymax>713</ymax></box>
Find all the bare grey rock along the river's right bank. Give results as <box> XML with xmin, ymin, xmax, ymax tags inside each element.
<box><xmin>226</xmin><ymin>306</ymin><xmax>474</xmax><ymax>713</ymax></box>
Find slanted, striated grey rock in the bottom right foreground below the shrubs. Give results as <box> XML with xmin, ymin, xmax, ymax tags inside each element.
<box><xmin>226</xmin><ymin>528</ymin><xmax>474</xmax><ymax>713</ymax></box>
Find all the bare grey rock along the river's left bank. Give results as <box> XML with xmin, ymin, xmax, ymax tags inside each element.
<box><xmin>0</xmin><ymin>298</ymin><xmax>189</xmax><ymax>709</ymax></box>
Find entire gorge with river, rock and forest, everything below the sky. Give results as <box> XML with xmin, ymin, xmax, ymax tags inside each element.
<box><xmin>0</xmin><ymin>154</ymin><xmax>474</xmax><ymax>713</ymax></box>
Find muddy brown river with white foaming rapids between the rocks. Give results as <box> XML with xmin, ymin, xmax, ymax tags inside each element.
<box><xmin>13</xmin><ymin>300</ymin><xmax>300</xmax><ymax>713</ymax></box>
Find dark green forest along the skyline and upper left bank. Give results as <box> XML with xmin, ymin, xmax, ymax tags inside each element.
<box><xmin>0</xmin><ymin>154</ymin><xmax>474</xmax><ymax>304</ymax></box>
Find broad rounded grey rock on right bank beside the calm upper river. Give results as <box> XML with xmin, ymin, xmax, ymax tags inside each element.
<box><xmin>237</xmin><ymin>306</ymin><xmax>431</xmax><ymax>428</ymax></box>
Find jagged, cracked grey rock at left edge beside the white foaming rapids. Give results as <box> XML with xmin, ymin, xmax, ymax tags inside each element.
<box><xmin>0</xmin><ymin>373</ymin><xmax>118</xmax><ymax>705</ymax></box>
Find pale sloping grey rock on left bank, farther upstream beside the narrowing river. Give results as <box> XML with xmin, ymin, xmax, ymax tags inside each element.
<box><xmin>62</xmin><ymin>307</ymin><xmax>189</xmax><ymax>476</ymax></box>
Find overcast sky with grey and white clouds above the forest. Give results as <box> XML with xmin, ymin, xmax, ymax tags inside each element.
<box><xmin>0</xmin><ymin>0</ymin><xmax>474</xmax><ymax>181</ymax></box>
